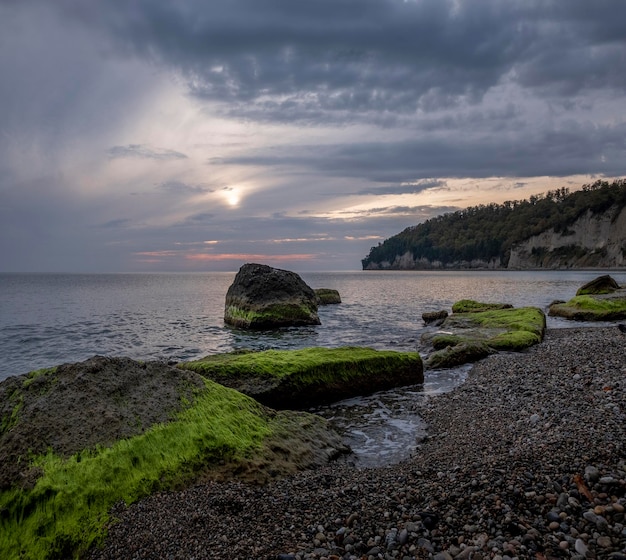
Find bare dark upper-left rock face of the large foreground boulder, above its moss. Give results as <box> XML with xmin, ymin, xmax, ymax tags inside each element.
<box><xmin>0</xmin><ymin>356</ymin><xmax>204</xmax><ymax>488</ymax></box>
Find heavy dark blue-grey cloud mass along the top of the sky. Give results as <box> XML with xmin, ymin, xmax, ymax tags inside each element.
<box><xmin>52</xmin><ymin>0</ymin><xmax>626</xmax><ymax>119</ymax></box>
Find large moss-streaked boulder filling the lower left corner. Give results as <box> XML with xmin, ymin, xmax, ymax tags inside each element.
<box><xmin>0</xmin><ymin>357</ymin><xmax>347</xmax><ymax>560</ymax></box>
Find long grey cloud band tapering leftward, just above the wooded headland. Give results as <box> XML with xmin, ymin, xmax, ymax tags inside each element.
<box><xmin>217</xmin><ymin>122</ymin><xmax>626</xmax><ymax>182</ymax></box>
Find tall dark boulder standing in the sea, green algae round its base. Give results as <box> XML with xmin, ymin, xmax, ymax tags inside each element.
<box><xmin>224</xmin><ymin>264</ymin><xmax>320</xmax><ymax>329</ymax></box>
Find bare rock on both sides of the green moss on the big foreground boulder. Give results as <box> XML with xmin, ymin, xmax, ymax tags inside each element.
<box><xmin>0</xmin><ymin>356</ymin><xmax>346</xmax><ymax>489</ymax></box>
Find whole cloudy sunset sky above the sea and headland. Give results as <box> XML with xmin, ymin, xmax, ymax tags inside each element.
<box><xmin>0</xmin><ymin>0</ymin><xmax>626</xmax><ymax>272</ymax></box>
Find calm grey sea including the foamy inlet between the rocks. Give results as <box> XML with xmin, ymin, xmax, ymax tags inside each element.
<box><xmin>0</xmin><ymin>270</ymin><xmax>626</xmax><ymax>467</ymax></box>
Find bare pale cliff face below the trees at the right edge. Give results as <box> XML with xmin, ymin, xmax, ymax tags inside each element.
<box><xmin>508</xmin><ymin>207</ymin><xmax>626</xmax><ymax>268</ymax></box>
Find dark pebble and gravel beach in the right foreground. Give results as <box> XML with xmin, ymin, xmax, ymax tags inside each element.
<box><xmin>90</xmin><ymin>327</ymin><xmax>626</xmax><ymax>560</ymax></box>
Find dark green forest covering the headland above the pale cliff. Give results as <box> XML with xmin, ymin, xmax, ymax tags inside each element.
<box><xmin>361</xmin><ymin>179</ymin><xmax>626</xmax><ymax>270</ymax></box>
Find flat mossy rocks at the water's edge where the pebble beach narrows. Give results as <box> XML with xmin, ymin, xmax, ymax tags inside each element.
<box><xmin>422</xmin><ymin>300</ymin><xmax>546</xmax><ymax>368</ymax></box>
